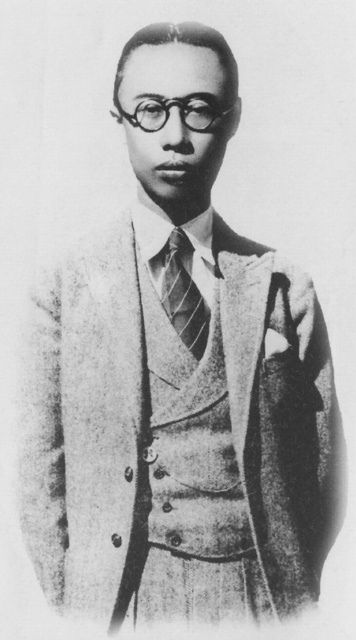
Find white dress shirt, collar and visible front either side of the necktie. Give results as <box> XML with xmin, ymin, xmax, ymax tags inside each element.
<box><xmin>131</xmin><ymin>190</ymin><xmax>216</xmax><ymax>308</ymax></box>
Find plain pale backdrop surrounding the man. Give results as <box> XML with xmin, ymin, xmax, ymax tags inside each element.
<box><xmin>0</xmin><ymin>0</ymin><xmax>356</xmax><ymax>640</ymax></box>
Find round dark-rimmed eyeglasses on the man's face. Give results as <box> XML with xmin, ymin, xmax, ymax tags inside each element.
<box><xmin>110</xmin><ymin>98</ymin><xmax>235</xmax><ymax>133</ymax></box>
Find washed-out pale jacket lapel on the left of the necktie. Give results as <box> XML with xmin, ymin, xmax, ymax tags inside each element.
<box><xmin>81</xmin><ymin>212</ymin><xmax>147</xmax><ymax>433</ymax></box>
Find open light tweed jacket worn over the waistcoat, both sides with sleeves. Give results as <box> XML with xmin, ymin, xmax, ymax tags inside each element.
<box><xmin>20</xmin><ymin>212</ymin><xmax>343</xmax><ymax>629</ymax></box>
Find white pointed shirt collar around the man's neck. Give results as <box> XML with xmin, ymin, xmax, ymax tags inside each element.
<box><xmin>131</xmin><ymin>185</ymin><xmax>215</xmax><ymax>266</ymax></box>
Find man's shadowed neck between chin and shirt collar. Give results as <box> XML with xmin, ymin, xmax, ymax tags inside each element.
<box><xmin>138</xmin><ymin>185</ymin><xmax>210</xmax><ymax>227</ymax></box>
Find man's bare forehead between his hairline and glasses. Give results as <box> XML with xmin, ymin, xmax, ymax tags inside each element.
<box><xmin>119</xmin><ymin>42</ymin><xmax>227</xmax><ymax>100</ymax></box>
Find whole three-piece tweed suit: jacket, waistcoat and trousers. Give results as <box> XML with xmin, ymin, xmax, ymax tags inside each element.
<box><xmin>21</xmin><ymin>212</ymin><xmax>344</xmax><ymax>629</ymax></box>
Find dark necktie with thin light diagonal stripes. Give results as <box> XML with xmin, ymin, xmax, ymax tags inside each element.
<box><xmin>162</xmin><ymin>227</ymin><xmax>210</xmax><ymax>360</ymax></box>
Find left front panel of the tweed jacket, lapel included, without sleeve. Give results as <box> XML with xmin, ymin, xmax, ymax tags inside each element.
<box><xmin>63</xmin><ymin>210</ymin><xmax>149</xmax><ymax>627</ymax></box>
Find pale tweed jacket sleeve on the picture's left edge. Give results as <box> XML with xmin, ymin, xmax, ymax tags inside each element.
<box><xmin>18</xmin><ymin>262</ymin><xmax>68</xmax><ymax>608</ymax></box>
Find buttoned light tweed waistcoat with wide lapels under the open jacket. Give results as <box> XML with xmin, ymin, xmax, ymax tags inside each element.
<box><xmin>138</xmin><ymin>249</ymin><xmax>254</xmax><ymax>560</ymax></box>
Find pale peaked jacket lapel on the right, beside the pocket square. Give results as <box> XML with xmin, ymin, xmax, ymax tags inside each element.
<box><xmin>218</xmin><ymin>251</ymin><xmax>274</xmax><ymax>462</ymax></box>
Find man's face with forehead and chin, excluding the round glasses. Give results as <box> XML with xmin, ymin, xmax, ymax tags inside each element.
<box><xmin>119</xmin><ymin>43</ymin><xmax>239</xmax><ymax>212</ymax></box>
